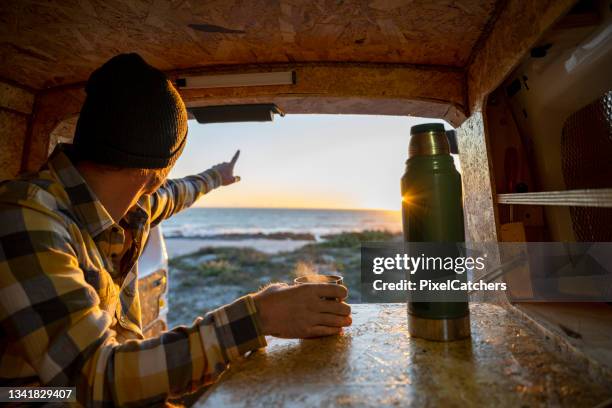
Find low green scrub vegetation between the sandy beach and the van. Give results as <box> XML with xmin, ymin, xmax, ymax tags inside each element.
<box><xmin>168</xmin><ymin>231</ymin><xmax>400</xmax><ymax>326</ymax></box>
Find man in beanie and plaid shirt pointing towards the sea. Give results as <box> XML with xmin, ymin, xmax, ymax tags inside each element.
<box><xmin>0</xmin><ymin>54</ymin><xmax>351</xmax><ymax>406</ymax></box>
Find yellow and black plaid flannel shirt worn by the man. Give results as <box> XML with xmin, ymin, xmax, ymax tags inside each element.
<box><xmin>0</xmin><ymin>145</ymin><xmax>266</xmax><ymax>406</ymax></box>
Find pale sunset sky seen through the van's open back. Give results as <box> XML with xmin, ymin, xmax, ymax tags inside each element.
<box><xmin>170</xmin><ymin>114</ymin><xmax>452</xmax><ymax>210</ymax></box>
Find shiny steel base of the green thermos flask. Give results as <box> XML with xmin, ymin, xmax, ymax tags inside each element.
<box><xmin>408</xmin><ymin>313</ymin><xmax>470</xmax><ymax>341</ymax></box>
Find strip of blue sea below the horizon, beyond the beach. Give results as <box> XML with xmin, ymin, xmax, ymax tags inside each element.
<box><xmin>162</xmin><ymin>208</ymin><xmax>402</xmax><ymax>240</ymax></box>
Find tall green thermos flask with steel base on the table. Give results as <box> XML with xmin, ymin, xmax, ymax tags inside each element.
<box><xmin>402</xmin><ymin>123</ymin><xmax>470</xmax><ymax>341</ymax></box>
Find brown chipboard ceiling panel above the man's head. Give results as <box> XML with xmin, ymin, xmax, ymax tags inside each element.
<box><xmin>0</xmin><ymin>0</ymin><xmax>495</xmax><ymax>89</ymax></box>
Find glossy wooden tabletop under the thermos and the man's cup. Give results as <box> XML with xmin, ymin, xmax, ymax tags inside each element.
<box><xmin>196</xmin><ymin>304</ymin><xmax>612</xmax><ymax>407</ymax></box>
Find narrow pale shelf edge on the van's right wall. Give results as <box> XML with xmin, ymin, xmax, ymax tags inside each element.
<box><xmin>497</xmin><ymin>188</ymin><xmax>612</xmax><ymax>208</ymax></box>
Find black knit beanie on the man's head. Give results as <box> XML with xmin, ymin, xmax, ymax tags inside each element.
<box><xmin>73</xmin><ymin>54</ymin><xmax>187</xmax><ymax>169</ymax></box>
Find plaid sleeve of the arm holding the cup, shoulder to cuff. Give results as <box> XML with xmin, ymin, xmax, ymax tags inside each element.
<box><xmin>0</xmin><ymin>197</ymin><xmax>266</xmax><ymax>406</ymax></box>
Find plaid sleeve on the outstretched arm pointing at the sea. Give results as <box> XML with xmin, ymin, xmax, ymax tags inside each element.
<box><xmin>150</xmin><ymin>169</ymin><xmax>221</xmax><ymax>226</ymax></box>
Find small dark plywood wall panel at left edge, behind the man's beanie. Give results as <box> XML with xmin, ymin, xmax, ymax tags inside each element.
<box><xmin>0</xmin><ymin>82</ymin><xmax>34</xmax><ymax>180</ymax></box>
